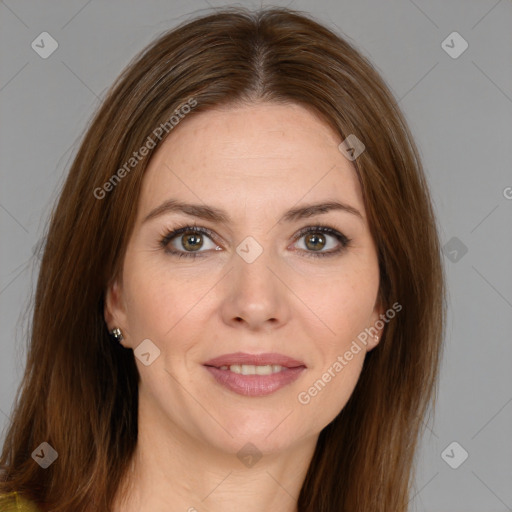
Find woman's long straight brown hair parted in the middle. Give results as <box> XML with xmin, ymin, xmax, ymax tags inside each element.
<box><xmin>0</xmin><ymin>8</ymin><xmax>445</xmax><ymax>512</ymax></box>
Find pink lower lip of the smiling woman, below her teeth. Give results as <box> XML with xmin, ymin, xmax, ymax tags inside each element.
<box><xmin>205</xmin><ymin>366</ymin><xmax>306</xmax><ymax>396</ymax></box>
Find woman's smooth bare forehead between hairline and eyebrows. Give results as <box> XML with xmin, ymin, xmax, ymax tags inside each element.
<box><xmin>141</xmin><ymin>103</ymin><xmax>364</xmax><ymax>220</ymax></box>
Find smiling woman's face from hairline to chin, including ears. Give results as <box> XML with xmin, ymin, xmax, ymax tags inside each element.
<box><xmin>106</xmin><ymin>103</ymin><xmax>381</xmax><ymax>453</ymax></box>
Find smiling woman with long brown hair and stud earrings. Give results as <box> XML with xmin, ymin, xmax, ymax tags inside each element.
<box><xmin>0</xmin><ymin>5</ymin><xmax>444</xmax><ymax>512</ymax></box>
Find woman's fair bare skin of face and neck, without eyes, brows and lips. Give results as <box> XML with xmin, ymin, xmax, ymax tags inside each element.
<box><xmin>105</xmin><ymin>103</ymin><xmax>383</xmax><ymax>512</ymax></box>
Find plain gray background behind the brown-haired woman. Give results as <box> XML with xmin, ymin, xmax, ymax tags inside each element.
<box><xmin>0</xmin><ymin>0</ymin><xmax>512</xmax><ymax>512</ymax></box>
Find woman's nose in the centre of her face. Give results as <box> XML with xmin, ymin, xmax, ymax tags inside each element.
<box><xmin>221</xmin><ymin>251</ymin><xmax>293</xmax><ymax>331</ymax></box>
